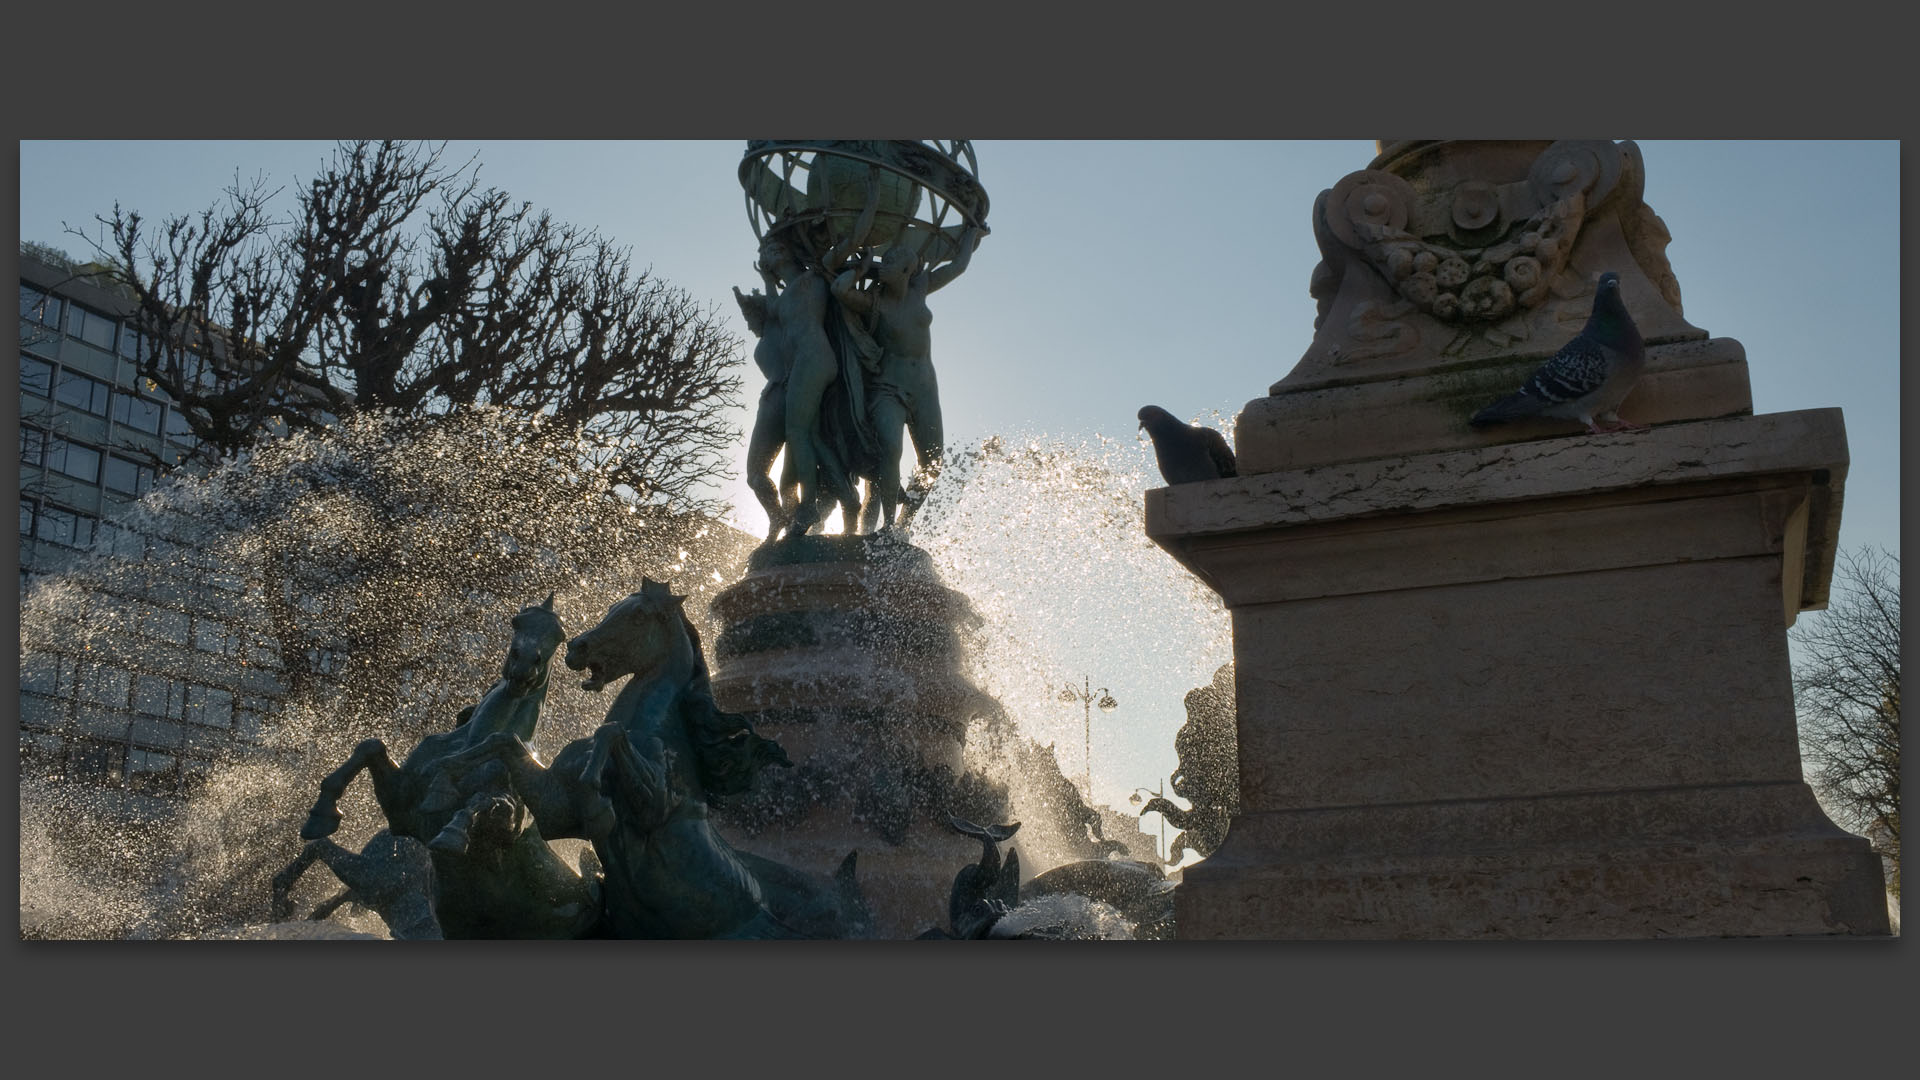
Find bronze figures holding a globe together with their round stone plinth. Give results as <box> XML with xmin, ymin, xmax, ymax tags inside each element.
<box><xmin>712</xmin><ymin>140</ymin><xmax>1152</xmax><ymax>938</ymax></box>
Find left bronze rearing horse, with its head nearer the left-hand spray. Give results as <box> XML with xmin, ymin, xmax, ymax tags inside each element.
<box><xmin>275</xmin><ymin>594</ymin><xmax>599</xmax><ymax>938</ymax></box>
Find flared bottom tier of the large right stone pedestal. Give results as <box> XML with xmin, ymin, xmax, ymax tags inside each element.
<box><xmin>1175</xmin><ymin>784</ymin><xmax>1887</xmax><ymax>940</ymax></box>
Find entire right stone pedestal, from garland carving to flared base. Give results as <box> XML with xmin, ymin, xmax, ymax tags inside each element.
<box><xmin>1146</xmin><ymin>140</ymin><xmax>1887</xmax><ymax>938</ymax></box>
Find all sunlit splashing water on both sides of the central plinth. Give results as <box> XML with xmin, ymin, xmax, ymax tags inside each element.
<box><xmin>21</xmin><ymin>411</ymin><xmax>1231</xmax><ymax>938</ymax></box>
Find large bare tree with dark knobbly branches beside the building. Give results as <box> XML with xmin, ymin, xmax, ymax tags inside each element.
<box><xmin>74</xmin><ymin>142</ymin><xmax>741</xmax><ymax>509</ymax></box>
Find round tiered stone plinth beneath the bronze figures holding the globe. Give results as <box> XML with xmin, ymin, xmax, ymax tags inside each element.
<box><xmin>712</xmin><ymin>536</ymin><xmax>1006</xmax><ymax>938</ymax></box>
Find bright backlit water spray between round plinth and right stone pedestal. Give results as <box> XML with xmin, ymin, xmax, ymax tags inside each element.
<box><xmin>914</xmin><ymin>426</ymin><xmax>1233</xmax><ymax>872</ymax></box>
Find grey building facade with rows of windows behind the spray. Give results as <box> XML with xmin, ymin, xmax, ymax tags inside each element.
<box><xmin>19</xmin><ymin>252</ymin><xmax>278</xmax><ymax>799</ymax></box>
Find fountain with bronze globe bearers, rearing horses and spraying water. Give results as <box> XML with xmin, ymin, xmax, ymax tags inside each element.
<box><xmin>21</xmin><ymin>144</ymin><xmax>1219</xmax><ymax>938</ymax></box>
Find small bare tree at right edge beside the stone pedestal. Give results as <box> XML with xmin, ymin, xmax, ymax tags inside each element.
<box><xmin>1793</xmin><ymin>548</ymin><xmax>1901</xmax><ymax>896</ymax></box>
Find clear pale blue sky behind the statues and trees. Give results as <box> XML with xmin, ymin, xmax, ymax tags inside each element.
<box><xmin>19</xmin><ymin>140</ymin><xmax>1899</xmax><ymax>849</ymax></box>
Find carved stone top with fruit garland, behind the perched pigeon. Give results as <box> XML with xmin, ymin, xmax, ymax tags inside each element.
<box><xmin>1235</xmin><ymin>138</ymin><xmax>1753</xmax><ymax>475</ymax></box>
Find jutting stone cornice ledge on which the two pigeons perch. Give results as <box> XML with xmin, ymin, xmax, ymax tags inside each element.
<box><xmin>1146</xmin><ymin>409</ymin><xmax>1847</xmax><ymax>625</ymax></box>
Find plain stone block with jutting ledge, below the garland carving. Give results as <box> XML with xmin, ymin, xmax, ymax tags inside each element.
<box><xmin>1146</xmin><ymin>409</ymin><xmax>1887</xmax><ymax>938</ymax></box>
